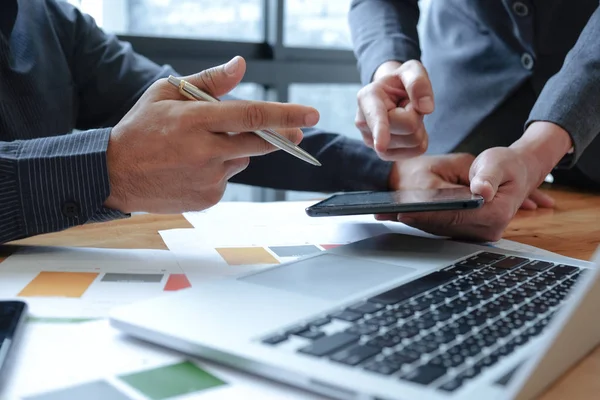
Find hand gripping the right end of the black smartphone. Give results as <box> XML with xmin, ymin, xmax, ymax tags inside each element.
<box><xmin>398</xmin><ymin>139</ymin><xmax>564</xmax><ymax>241</ymax></box>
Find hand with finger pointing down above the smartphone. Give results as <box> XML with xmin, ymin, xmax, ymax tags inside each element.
<box><xmin>355</xmin><ymin>60</ymin><xmax>434</xmax><ymax>161</ymax></box>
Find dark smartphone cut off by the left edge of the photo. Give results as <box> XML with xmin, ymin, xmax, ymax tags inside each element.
<box><xmin>0</xmin><ymin>301</ymin><xmax>27</xmax><ymax>384</ymax></box>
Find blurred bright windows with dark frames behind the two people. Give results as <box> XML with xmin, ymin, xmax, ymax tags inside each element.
<box><xmin>65</xmin><ymin>0</ymin><xmax>430</xmax><ymax>201</ymax></box>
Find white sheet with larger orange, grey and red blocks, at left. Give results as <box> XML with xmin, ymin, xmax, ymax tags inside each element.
<box><xmin>0</xmin><ymin>247</ymin><xmax>191</xmax><ymax>318</ymax></box>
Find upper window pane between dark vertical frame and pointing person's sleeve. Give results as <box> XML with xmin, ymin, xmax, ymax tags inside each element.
<box><xmin>283</xmin><ymin>0</ymin><xmax>352</xmax><ymax>49</ymax></box>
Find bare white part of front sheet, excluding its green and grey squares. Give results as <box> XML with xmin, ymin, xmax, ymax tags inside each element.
<box><xmin>0</xmin><ymin>320</ymin><xmax>321</xmax><ymax>400</ymax></box>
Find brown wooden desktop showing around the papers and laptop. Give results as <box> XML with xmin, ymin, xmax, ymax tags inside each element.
<box><xmin>5</xmin><ymin>190</ymin><xmax>600</xmax><ymax>400</ymax></box>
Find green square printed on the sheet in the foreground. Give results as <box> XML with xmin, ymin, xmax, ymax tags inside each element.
<box><xmin>119</xmin><ymin>361</ymin><xmax>226</xmax><ymax>400</ymax></box>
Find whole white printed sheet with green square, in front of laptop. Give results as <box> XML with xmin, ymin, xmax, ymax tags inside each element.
<box><xmin>0</xmin><ymin>320</ymin><xmax>321</xmax><ymax>400</ymax></box>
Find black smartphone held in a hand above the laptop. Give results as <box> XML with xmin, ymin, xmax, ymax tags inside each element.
<box><xmin>306</xmin><ymin>187</ymin><xmax>483</xmax><ymax>217</ymax></box>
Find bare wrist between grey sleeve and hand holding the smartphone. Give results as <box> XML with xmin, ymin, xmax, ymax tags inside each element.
<box><xmin>510</xmin><ymin>121</ymin><xmax>573</xmax><ymax>184</ymax></box>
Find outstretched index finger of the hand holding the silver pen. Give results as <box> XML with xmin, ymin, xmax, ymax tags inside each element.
<box><xmin>180</xmin><ymin>100</ymin><xmax>319</xmax><ymax>132</ymax></box>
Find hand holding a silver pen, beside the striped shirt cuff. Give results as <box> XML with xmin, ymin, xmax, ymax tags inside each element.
<box><xmin>105</xmin><ymin>57</ymin><xmax>319</xmax><ymax>213</ymax></box>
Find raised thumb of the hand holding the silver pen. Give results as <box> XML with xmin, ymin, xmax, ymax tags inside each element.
<box><xmin>182</xmin><ymin>56</ymin><xmax>246</xmax><ymax>97</ymax></box>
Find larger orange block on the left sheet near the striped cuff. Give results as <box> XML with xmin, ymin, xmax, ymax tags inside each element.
<box><xmin>18</xmin><ymin>272</ymin><xmax>98</xmax><ymax>298</ymax></box>
